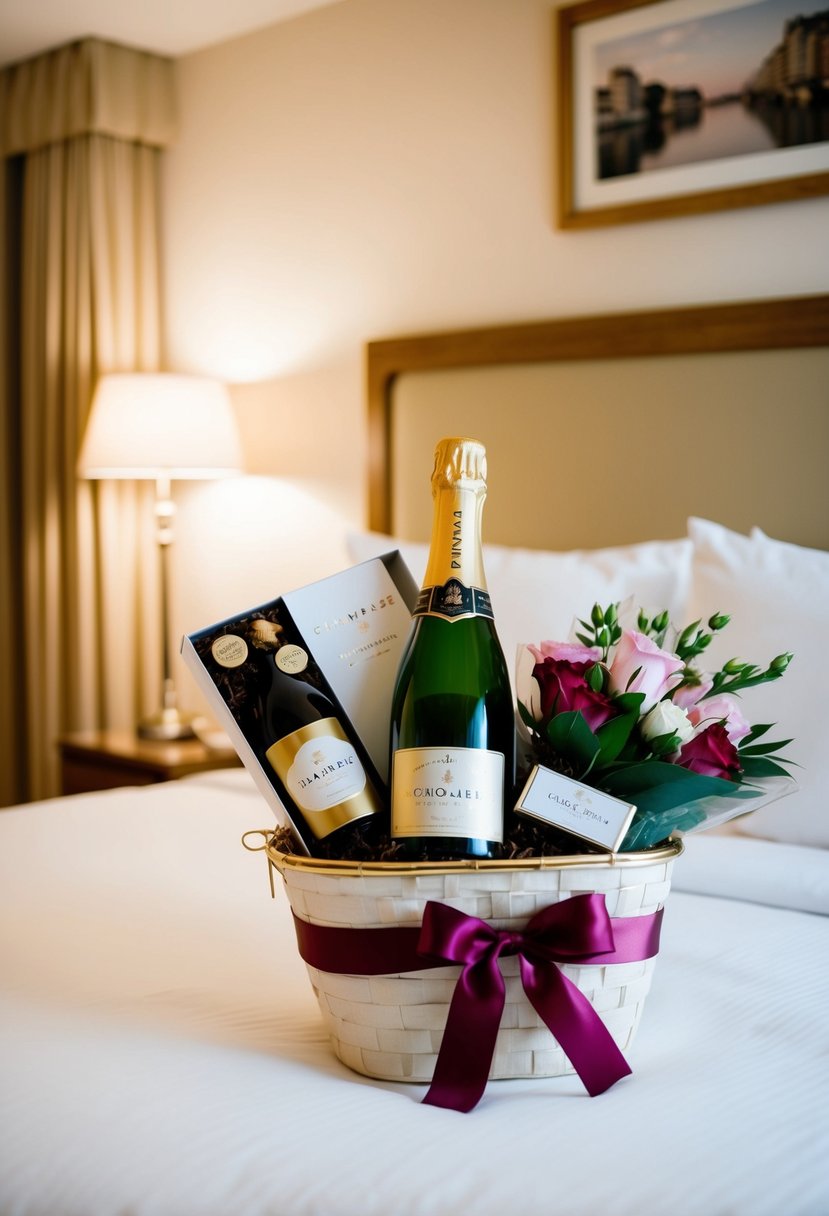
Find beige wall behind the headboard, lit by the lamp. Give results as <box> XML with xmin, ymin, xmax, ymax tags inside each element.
<box><xmin>164</xmin><ymin>0</ymin><xmax>829</xmax><ymax>710</ymax></box>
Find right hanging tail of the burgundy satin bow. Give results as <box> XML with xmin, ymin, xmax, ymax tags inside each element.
<box><xmin>520</xmin><ymin>957</ymin><xmax>632</xmax><ymax>1098</ymax></box>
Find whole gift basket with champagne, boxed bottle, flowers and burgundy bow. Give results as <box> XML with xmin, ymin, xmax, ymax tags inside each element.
<box><xmin>195</xmin><ymin>439</ymin><xmax>795</xmax><ymax>1111</ymax></box>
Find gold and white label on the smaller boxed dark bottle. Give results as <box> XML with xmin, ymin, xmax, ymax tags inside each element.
<box><xmin>265</xmin><ymin>717</ymin><xmax>378</xmax><ymax>840</ymax></box>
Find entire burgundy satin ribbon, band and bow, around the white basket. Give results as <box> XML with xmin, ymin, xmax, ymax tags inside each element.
<box><xmin>294</xmin><ymin>894</ymin><xmax>662</xmax><ymax>1111</ymax></box>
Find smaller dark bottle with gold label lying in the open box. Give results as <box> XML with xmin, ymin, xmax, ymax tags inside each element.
<box><xmin>248</xmin><ymin>620</ymin><xmax>382</xmax><ymax>851</ymax></box>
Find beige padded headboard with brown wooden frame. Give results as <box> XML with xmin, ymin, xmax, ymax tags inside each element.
<box><xmin>367</xmin><ymin>295</ymin><xmax>829</xmax><ymax>550</ymax></box>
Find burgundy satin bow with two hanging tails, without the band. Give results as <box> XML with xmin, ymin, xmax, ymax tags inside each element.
<box><xmin>418</xmin><ymin>894</ymin><xmax>627</xmax><ymax>1111</ymax></box>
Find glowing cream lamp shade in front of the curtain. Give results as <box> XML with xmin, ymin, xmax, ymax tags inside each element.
<box><xmin>78</xmin><ymin>372</ymin><xmax>242</xmax><ymax>479</ymax></box>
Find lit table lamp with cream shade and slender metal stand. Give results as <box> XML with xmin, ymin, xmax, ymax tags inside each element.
<box><xmin>78</xmin><ymin>372</ymin><xmax>242</xmax><ymax>739</ymax></box>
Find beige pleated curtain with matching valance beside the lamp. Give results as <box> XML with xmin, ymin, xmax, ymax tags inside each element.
<box><xmin>0</xmin><ymin>39</ymin><xmax>174</xmax><ymax>805</ymax></box>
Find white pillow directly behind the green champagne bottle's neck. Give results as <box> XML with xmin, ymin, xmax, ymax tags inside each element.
<box><xmin>346</xmin><ymin>533</ymin><xmax>692</xmax><ymax>676</ymax></box>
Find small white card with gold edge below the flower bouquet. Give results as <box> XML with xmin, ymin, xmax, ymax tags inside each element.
<box><xmin>515</xmin><ymin>765</ymin><xmax>636</xmax><ymax>852</ymax></box>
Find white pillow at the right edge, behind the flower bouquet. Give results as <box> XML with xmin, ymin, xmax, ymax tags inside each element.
<box><xmin>688</xmin><ymin>519</ymin><xmax>829</xmax><ymax>848</ymax></box>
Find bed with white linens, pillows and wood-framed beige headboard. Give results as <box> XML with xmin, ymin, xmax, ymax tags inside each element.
<box><xmin>0</xmin><ymin>297</ymin><xmax>829</xmax><ymax>1216</ymax></box>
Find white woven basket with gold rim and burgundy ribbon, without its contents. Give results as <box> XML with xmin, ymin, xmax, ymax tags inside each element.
<box><xmin>246</xmin><ymin>840</ymin><xmax>682</xmax><ymax>1110</ymax></box>
